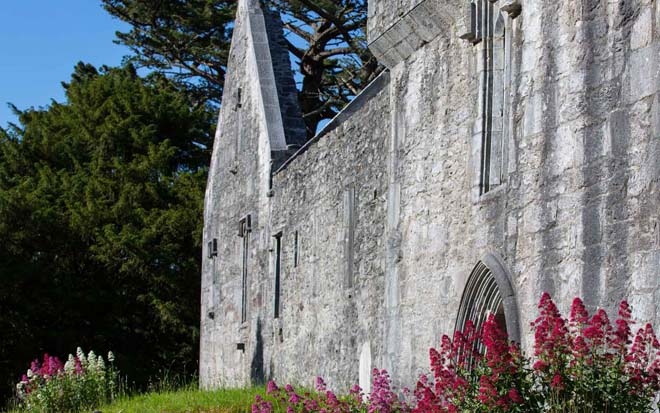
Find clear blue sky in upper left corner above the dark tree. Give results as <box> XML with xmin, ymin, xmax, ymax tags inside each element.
<box><xmin>0</xmin><ymin>0</ymin><xmax>129</xmax><ymax>127</ymax></box>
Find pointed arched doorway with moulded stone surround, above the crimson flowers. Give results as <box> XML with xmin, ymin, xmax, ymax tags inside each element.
<box><xmin>456</xmin><ymin>254</ymin><xmax>520</xmax><ymax>342</ymax></box>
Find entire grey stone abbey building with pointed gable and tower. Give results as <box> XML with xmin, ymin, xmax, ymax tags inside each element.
<box><xmin>200</xmin><ymin>0</ymin><xmax>660</xmax><ymax>389</ymax></box>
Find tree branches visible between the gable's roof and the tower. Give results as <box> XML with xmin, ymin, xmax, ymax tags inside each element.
<box><xmin>267</xmin><ymin>0</ymin><xmax>383</xmax><ymax>135</ymax></box>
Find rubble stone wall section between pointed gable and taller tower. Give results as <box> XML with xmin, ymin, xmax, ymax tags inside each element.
<box><xmin>268</xmin><ymin>73</ymin><xmax>390</xmax><ymax>390</ymax></box>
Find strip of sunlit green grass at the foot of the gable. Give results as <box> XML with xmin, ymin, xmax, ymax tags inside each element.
<box><xmin>99</xmin><ymin>387</ymin><xmax>264</xmax><ymax>413</ymax></box>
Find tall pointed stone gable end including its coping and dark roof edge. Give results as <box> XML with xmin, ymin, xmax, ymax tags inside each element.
<box><xmin>200</xmin><ymin>0</ymin><xmax>305</xmax><ymax>387</ymax></box>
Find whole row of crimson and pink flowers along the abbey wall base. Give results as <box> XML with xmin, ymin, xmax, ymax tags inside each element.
<box><xmin>252</xmin><ymin>293</ymin><xmax>660</xmax><ymax>413</ymax></box>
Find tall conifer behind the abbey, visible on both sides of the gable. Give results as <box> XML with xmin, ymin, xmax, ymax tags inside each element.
<box><xmin>102</xmin><ymin>0</ymin><xmax>382</xmax><ymax>136</ymax></box>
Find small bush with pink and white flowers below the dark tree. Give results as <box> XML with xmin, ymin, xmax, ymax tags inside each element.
<box><xmin>16</xmin><ymin>347</ymin><xmax>118</xmax><ymax>413</ymax></box>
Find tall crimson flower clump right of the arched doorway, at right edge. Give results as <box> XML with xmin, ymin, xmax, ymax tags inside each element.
<box><xmin>532</xmin><ymin>293</ymin><xmax>660</xmax><ymax>411</ymax></box>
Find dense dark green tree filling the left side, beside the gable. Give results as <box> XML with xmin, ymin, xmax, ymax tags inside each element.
<box><xmin>0</xmin><ymin>64</ymin><xmax>213</xmax><ymax>400</ymax></box>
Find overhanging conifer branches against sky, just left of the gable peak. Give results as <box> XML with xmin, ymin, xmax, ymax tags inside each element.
<box><xmin>102</xmin><ymin>0</ymin><xmax>236</xmax><ymax>105</ymax></box>
